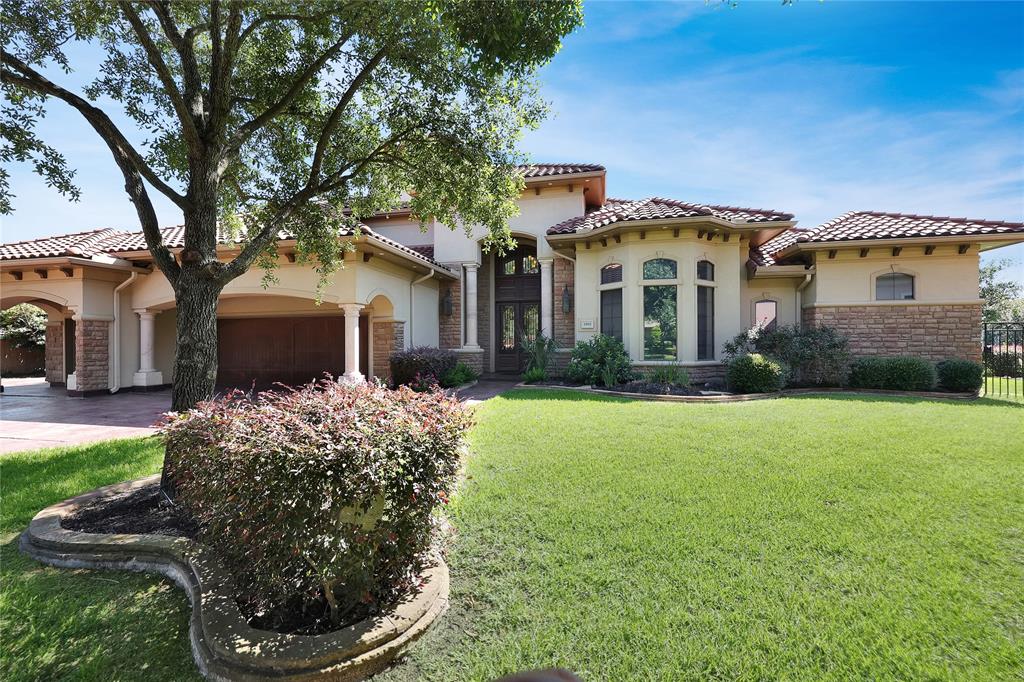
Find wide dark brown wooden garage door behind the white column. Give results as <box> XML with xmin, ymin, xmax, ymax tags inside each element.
<box><xmin>217</xmin><ymin>315</ymin><xmax>368</xmax><ymax>390</ymax></box>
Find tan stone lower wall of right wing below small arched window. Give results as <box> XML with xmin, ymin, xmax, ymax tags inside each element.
<box><xmin>803</xmin><ymin>303</ymin><xmax>981</xmax><ymax>361</ymax></box>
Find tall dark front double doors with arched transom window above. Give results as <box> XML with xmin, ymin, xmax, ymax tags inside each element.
<box><xmin>495</xmin><ymin>240</ymin><xmax>541</xmax><ymax>374</ymax></box>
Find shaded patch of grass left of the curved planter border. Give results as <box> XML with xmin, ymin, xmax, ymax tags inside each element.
<box><xmin>0</xmin><ymin>438</ymin><xmax>202</xmax><ymax>682</ymax></box>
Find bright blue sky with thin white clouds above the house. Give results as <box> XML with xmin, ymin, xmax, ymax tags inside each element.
<box><xmin>2</xmin><ymin>0</ymin><xmax>1024</xmax><ymax>281</ymax></box>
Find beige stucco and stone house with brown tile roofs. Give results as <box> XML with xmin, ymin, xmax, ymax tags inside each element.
<box><xmin>0</xmin><ymin>164</ymin><xmax>1024</xmax><ymax>395</ymax></box>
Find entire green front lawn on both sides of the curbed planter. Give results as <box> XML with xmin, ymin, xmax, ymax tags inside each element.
<box><xmin>0</xmin><ymin>390</ymin><xmax>1024</xmax><ymax>681</ymax></box>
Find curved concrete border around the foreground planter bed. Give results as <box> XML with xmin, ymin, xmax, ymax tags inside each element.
<box><xmin>19</xmin><ymin>475</ymin><xmax>449</xmax><ymax>682</ymax></box>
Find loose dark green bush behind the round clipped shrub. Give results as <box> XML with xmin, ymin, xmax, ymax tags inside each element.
<box><xmin>723</xmin><ymin>326</ymin><xmax>850</xmax><ymax>386</ymax></box>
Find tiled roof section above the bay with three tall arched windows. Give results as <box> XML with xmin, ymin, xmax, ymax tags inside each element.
<box><xmin>548</xmin><ymin>197</ymin><xmax>793</xmax><ymax>235</ymax></box>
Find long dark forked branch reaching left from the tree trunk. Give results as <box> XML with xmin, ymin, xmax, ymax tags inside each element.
<box><xmin>0</xmin><ymin>50</ymin><xmax>182</xmax><ymax>284</ymax></box>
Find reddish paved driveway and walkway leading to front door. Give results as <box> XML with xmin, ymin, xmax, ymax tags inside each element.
<box><xmin>0</xmin><ymin>378</ymin><xmax>515</xmax><ymax>455</ymax></box>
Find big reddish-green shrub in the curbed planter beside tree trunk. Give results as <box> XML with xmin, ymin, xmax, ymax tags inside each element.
<box><xmin>162</xmin><ymin>380</ymin><xmax>470</xmax><ymax>625</ymax></box>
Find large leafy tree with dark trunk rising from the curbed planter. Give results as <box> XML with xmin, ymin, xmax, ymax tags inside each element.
<box><xmin>0</xmin><ymin>0</ymin><xmax>582</xmax><ymax>410</ymax></box>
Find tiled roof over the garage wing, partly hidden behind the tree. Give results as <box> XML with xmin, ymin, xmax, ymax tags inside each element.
<box><xmin>0</xmin><ymin>225</ymin><xmax>447</xmax><ymax>270</ymax></box>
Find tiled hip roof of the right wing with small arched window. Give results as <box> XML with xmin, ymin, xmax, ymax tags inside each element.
<box><xmin>797</xmin><ymin>211</ymin><xmax>1024</xmax><ymax>243</ymax></box>
